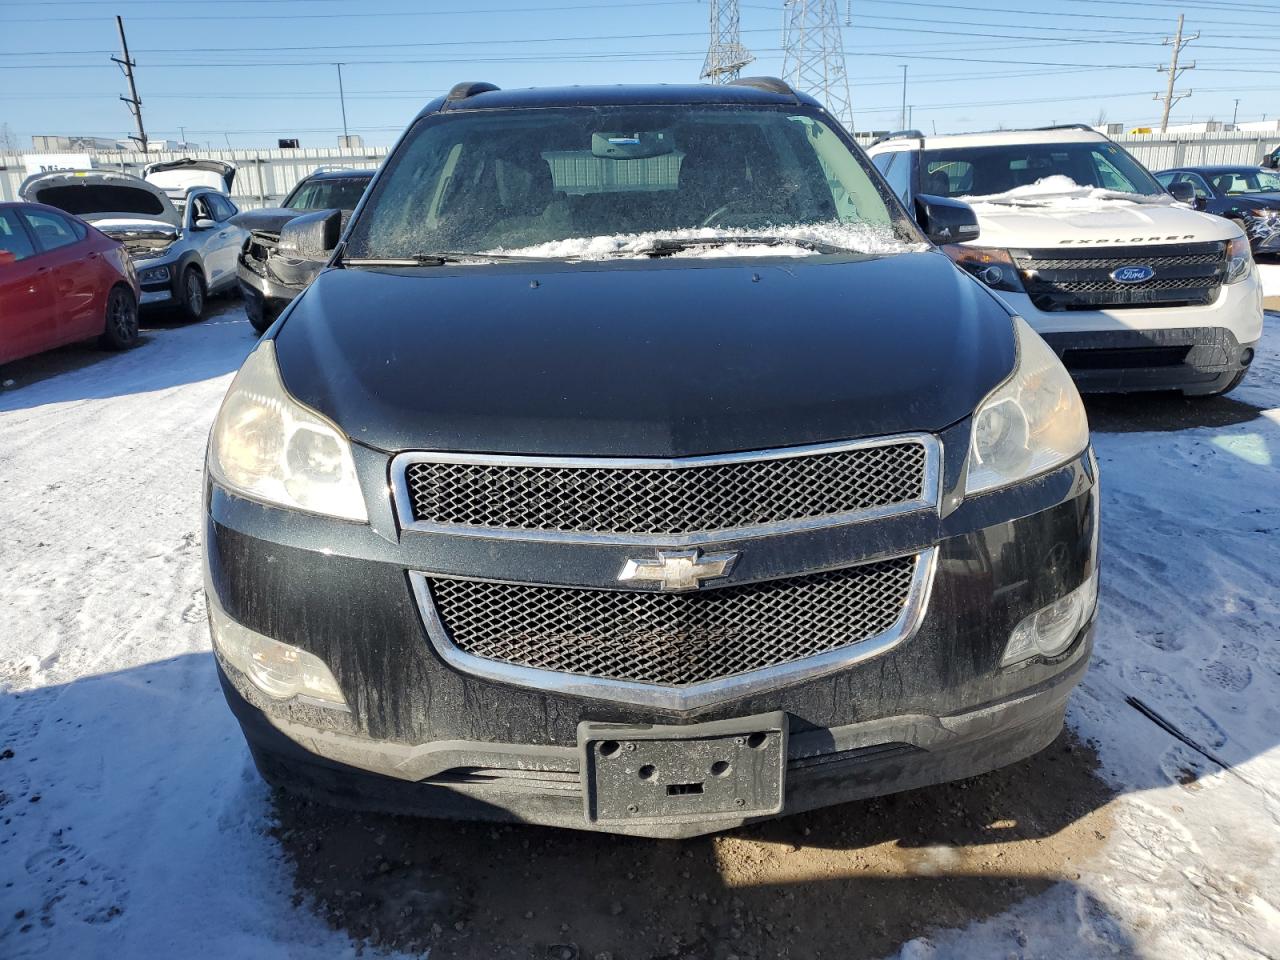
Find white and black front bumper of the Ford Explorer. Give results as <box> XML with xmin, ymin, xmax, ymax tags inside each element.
<box><xmin>998</xmin><ymin>270</ymin><xmax>1262</xmax><ymax>396</ymax></box>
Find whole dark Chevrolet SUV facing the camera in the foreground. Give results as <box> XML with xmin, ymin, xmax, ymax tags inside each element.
<box><xmin>204</xmin><ymin>79</ymin><xmax>1098</xmax><ymax>836</ymax></box>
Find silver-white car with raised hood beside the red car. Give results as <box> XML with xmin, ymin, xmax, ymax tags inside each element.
<box><xmin>19</xmin><ymin>160</ymin><xmax>246</xmax><ymax>320</ymax></box>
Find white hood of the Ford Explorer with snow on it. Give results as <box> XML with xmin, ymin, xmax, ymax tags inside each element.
<box><xmin>972</xmin><ymin>200</ymin><xmax>1236</xmax><ymax>248</ymax></box>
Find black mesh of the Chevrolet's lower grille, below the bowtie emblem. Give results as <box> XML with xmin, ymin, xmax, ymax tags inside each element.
<box><xmin>426</xmin><ymin>556</ymin><xmax>923</xmax><ymax>687</ymax></box>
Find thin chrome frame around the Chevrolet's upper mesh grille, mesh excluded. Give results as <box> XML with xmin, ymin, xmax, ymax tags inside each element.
<box><xmin>390</xmin><ymin>433</ymin><xmax>942</xmax><ymax>547</ymax></box>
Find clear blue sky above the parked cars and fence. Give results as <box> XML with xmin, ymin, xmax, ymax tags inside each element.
<box><xmin>0</xmin><ymin>0</ymin><xmax>1280</xmax><ymax>147</ymax></box>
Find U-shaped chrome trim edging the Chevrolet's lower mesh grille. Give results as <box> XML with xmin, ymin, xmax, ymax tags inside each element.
<box><xmin>408</xmin><ymin>547</ymin><xmax>938</xmax><ymax>710</ymax></box>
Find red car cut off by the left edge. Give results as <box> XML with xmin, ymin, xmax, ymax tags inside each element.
<box><xmin>0</xmin><ymin>204</ymin><xmax>138</xmax><ymax>364</ymax></box>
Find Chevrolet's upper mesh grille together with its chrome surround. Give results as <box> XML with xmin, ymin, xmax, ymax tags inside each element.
<box><xmin>390</xmin><ymin>434</ymin><xmax>941</xmax><ymax>547</ymax></box>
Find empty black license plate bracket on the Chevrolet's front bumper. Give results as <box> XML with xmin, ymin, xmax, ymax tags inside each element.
<box><xmin>577</xmin><ymin>713</ymin><xmax>787</xmax><ymax>824</ymax></box>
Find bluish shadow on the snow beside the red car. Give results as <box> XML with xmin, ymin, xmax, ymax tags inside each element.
<box><xmin>0</xmin><ymin>301</ymin><xmax>257</xmax><ymax>412</ymax></box>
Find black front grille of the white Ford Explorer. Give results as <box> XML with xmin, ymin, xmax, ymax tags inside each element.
<box><xmin>1014</xmin><ymin>242</ymin><xmax>1226</xmax><ymax>311</ymax></box>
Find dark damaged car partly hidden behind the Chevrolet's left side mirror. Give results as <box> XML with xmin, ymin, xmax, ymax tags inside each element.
<box><xmin>236</xmin><ymin>168</ymin><xmax>374</xmax><ymax>332</ymax></box>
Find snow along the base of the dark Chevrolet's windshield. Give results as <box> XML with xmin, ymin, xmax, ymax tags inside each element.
<box><xmin>486</xmin><ymin>223</ymin><xmax>928</xmax><ymax>260</ymax></box>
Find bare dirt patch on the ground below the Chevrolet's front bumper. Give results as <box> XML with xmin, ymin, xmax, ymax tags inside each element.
<box><xmin>276</xmin><ymin>733</ymin><xmax>1111</xmax><ymax>960</ymax></box>
